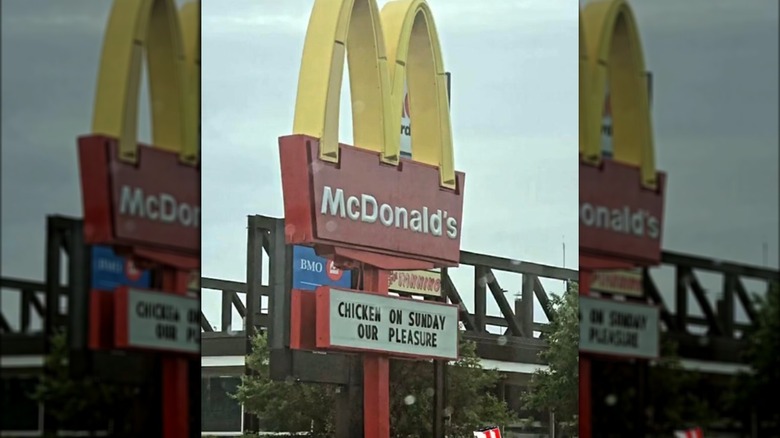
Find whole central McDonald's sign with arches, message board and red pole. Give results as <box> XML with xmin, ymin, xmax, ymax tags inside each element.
<box><xmin>279</xmin><ymin>0</ymin><xmax>465</xmax><ymax>438</ymax></box>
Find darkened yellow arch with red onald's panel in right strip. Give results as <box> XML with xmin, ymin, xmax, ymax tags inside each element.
<box><xmin>579</xmin><ymin>0</ymin><xmax>666</xmax><ymax>268</ymax></box>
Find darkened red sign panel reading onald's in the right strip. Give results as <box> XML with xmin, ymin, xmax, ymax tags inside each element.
<box><xmin>579</xmin><ymin>159</ymin><xmax>666</xmax><ymax>265</ymax></box>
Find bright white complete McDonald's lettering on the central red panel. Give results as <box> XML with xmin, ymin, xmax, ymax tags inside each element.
<box><xmin>320</xmin><ymin>186</ymin><xmax>458</xmax><ymax>239</ymax></box>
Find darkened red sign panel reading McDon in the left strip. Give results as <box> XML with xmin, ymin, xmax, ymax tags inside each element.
<box><xmin>79</xmin><ymin>135</ymin><xmax>200</xmax><ymax>257</ymax></box>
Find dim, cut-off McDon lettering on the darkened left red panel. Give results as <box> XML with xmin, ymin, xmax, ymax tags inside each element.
<box><xmin>119</xmin><ymin>185</ymin><xmax>200</xmax><ymax>228</ymax></box>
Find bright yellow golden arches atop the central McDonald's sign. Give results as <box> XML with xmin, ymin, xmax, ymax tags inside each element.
<box><xmin>293</xmin><ymin>0</ymin><xmax>456</xmax><ymax>188</ymax></box>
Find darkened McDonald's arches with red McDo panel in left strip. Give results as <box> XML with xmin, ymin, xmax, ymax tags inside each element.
<box><xmin>78</xmin><ymin>0</ymin><xmax>200</xmax><ymax>258</ymax></box>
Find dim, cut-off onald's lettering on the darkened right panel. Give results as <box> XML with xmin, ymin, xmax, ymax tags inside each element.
<box><xmin>580</xmin><ymin>202</ymin><xmax>661</xmax><ymax>239</ymax></box>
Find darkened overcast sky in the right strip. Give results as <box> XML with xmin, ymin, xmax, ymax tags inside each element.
<box><xmin>620</xmin><ymin>0</ymin><xmax>780</xmax><ymax>319</ymax></box>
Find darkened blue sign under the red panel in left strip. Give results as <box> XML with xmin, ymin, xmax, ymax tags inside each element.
<box><xmin>92</xmin><ymin>246</ymin><xmax>151</xmax><ymax>291</ymax></box>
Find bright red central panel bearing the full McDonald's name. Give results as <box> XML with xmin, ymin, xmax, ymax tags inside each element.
<box><xmin>279</xmin><ymin>135</ymin><xmax>465</xmax><ymax>269</ymax></box>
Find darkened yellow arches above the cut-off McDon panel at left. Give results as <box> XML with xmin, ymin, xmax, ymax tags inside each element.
<box><xmin>92</xmin><ymin>0</ymin><xmax>199</xmax><ymax>165</ymax></box>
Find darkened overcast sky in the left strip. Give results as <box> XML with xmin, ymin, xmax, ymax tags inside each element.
<box><xmin>0</xmin><ymin>0</ymin><xmax>185</xmax><ymax>326</ymax></box>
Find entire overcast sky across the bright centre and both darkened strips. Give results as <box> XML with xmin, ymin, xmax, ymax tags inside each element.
<box><xmin>1</xmin><ymin>0</ymin><xmax>778</xmax><ymax>334</ymax></box>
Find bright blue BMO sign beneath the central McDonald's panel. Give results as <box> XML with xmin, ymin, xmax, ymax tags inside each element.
<box><xmin>293</xmin><ymin>246</ymin><xmax>352</xmax><ymax>290</ymax></box>
